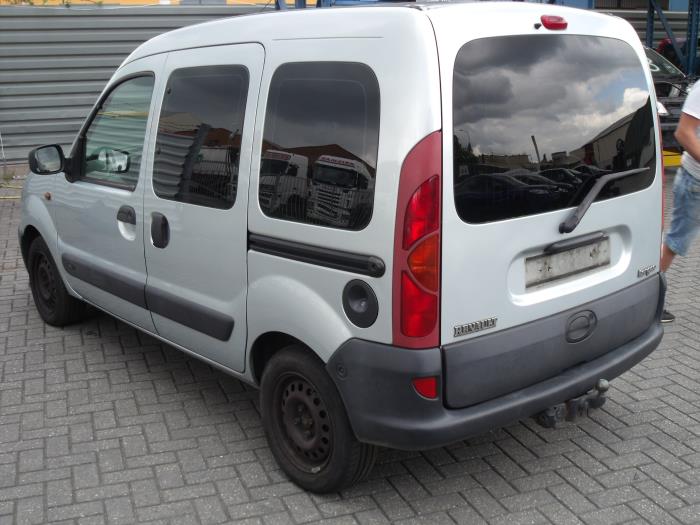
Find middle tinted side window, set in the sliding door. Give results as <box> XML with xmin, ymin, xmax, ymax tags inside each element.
<box><xmin>153</xmin><ymin>66</ymin><xmax>249</xmax><ymax>209</ymax></box>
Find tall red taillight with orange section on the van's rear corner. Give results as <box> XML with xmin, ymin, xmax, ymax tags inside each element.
<box><xmin>393</xmin><ymin>131</ymin><xmax>442</xmax><ymax>348</ymax></box>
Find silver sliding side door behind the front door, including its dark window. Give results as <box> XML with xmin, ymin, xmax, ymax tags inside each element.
<box><xmin>144</xmin><ymin>44</ymin><xmax>264</xmax><ymax>371</ymax></box>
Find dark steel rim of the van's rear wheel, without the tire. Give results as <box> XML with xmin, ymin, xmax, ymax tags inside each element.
<box><xmin>275</xmin><ymin>373</ymin><xmax>333</xmax><ymax>473</ymax></box>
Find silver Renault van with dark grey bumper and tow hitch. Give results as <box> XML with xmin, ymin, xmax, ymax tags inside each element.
<box><xmin>19</xmin><ymin>2</ymin><xmax>665</xmax><ymax>492</ymax></box>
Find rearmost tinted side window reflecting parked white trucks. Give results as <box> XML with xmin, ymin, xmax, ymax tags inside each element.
<box><xmin>258</xmin><ymin>62</ymin><xmax>379</xmax><ymax>230</ymax></box>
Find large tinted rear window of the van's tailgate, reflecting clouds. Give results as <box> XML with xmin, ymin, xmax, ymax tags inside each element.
<box><xmin>452</xmin><ymin>35</ymin><xmax>656</xmax><ymax>223</ymax></box>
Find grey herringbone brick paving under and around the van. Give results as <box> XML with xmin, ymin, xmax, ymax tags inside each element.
<box><xmin>0</xmin><ymin>173</ymin><xmax>700</xmax><ymax>525</ymax></box>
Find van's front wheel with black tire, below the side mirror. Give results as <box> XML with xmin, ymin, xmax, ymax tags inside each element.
<box><xmin>27</xmin><ymin>237</ymin><xmax>87</xmax><ymax>326</ymax></box>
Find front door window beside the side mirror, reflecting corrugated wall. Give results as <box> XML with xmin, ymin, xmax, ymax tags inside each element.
<box><xmin>81</xmin><ymin>76</ymin><xmax>153</xmax><ymax>191</ymax></box>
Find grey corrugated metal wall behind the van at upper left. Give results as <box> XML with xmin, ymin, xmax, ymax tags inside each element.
<box><xmin>0</xmin><ymin>5</ymin><xmax>263</xmax><ymax>163</ymax></box>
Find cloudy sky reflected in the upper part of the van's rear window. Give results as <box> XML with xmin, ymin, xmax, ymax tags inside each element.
<box><xmin>453</xmin><ymin>35</ymin><xmax>649</xmax><ymax>161</ymax></box>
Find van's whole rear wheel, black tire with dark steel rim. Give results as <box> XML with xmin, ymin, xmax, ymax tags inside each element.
<box><xmin>260</xmin><ymin>345</ymin><xmax>377</xmax><ymax>493</ymax></box>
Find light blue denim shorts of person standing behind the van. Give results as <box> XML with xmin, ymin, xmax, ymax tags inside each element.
<box><xmin>665</xmin><ymin>167</ymin><xmax>700</xmax><ymax>255</ymax></box>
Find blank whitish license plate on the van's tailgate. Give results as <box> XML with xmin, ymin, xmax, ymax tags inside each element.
<box><xmin>525</xmin><ymin>238</ymin><xmax>610</xmax><ymax>288</ymax></box>
